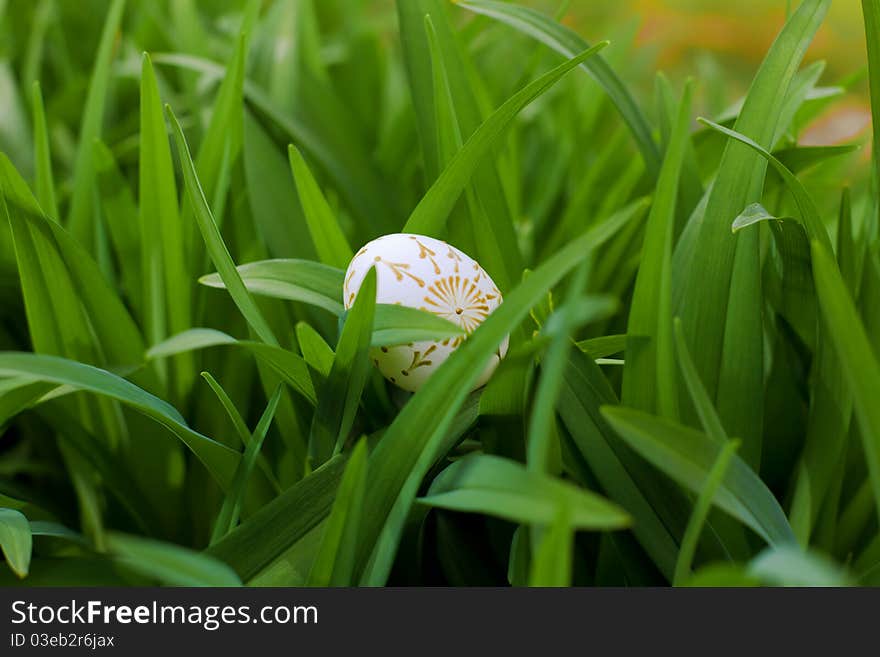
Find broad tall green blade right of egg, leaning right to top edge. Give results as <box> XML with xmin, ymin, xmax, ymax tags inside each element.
<box><xmin>677</xmin><ymin>0</ymin><xmax>830</xmax><ymax>472</ymax></box>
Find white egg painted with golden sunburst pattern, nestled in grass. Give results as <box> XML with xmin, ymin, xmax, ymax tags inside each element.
<box><xmin>343</xmin><ymin>233</ymin><xmax>508</xmax><ymax>392</ymax></box>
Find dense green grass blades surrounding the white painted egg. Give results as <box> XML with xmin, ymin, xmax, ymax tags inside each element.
<box><xmin>0</xmin><ymin>0</ymin><xmax>880</xmax><ymax>586</ymax></box>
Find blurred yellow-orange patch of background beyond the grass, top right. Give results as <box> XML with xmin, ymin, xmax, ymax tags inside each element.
<box><xmin>556</xmin><ymin>0</ymin><xmax>870</xmax><ymax>144</ymax></box>
